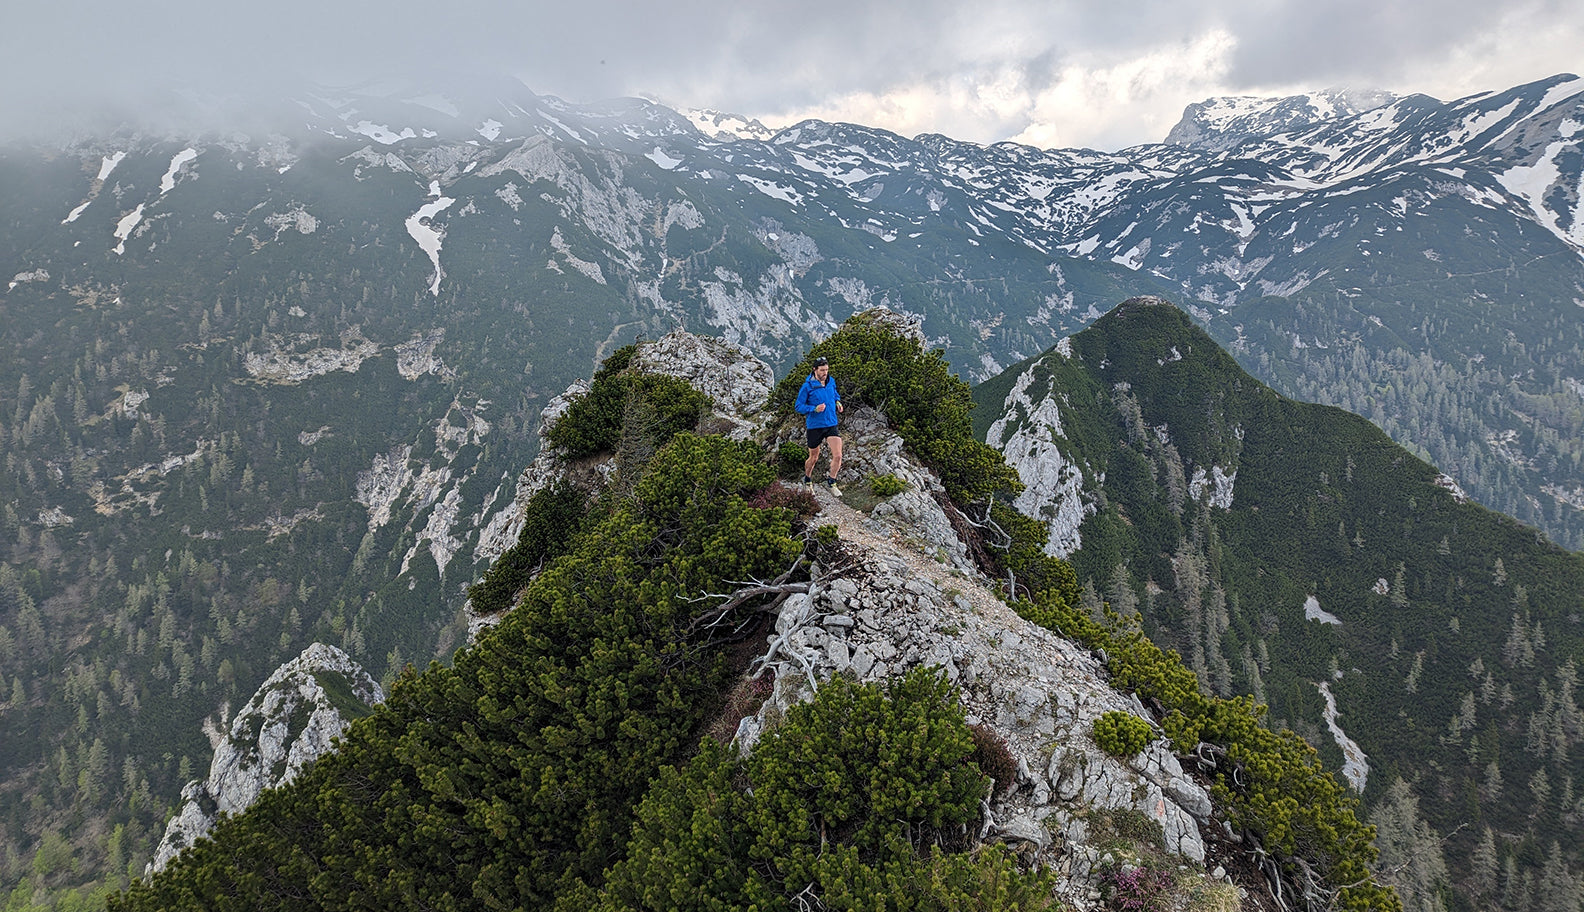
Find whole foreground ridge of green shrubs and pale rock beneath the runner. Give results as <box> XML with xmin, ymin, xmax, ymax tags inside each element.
<box><xmin>111</xmin><ymin>314</ymin><xmax>1399</xmax><ymax>910</ymax></box>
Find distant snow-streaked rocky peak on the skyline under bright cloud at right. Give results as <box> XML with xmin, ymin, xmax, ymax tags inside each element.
<box><xmin>1166</xmin><ymin>87</ymin><xmax>1397</xmax><ymax>152</ymax></box>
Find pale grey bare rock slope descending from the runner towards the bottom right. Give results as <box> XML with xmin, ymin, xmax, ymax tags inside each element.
<box><xmin>737</xmin><ymin>475</ymin><xmax>1215</xmax><ymax>909</ymax></box>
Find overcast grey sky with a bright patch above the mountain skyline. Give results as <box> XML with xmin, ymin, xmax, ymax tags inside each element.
<box><xmin>0</xmin><ymin>0</ymin><xmax>1584</xmax><ymax>150</ymax></box>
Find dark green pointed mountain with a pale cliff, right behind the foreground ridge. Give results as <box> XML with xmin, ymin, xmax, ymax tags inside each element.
<box><xmin>976</xmin><ymin>299</ymin><xmax>1584</xmax><ymax>909</ymax></box>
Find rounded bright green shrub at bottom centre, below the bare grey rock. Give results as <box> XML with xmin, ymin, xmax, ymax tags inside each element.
<box><xmin>596</xmin><ymin>670</ymin><xmax>1057</xmax><ymax>912</ymax></box>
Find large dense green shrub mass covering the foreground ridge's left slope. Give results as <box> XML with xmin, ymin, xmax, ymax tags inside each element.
<box><xmin>109</xmin><ymin>434</ymin><xmax>803</xmax><ymax>912</ymax></box>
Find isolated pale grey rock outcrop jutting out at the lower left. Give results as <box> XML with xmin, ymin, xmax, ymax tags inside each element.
<box><xmin>147</xmin><ymin>643</ymin><xmax>385</xmax><ymax>872</ymax></box>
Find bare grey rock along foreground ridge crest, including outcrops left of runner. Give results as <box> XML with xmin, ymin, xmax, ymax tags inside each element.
<box><xmin>474</xmin><ymin>312</ymin><xmax>1247</xmax><ymax>909</ymax></box>
